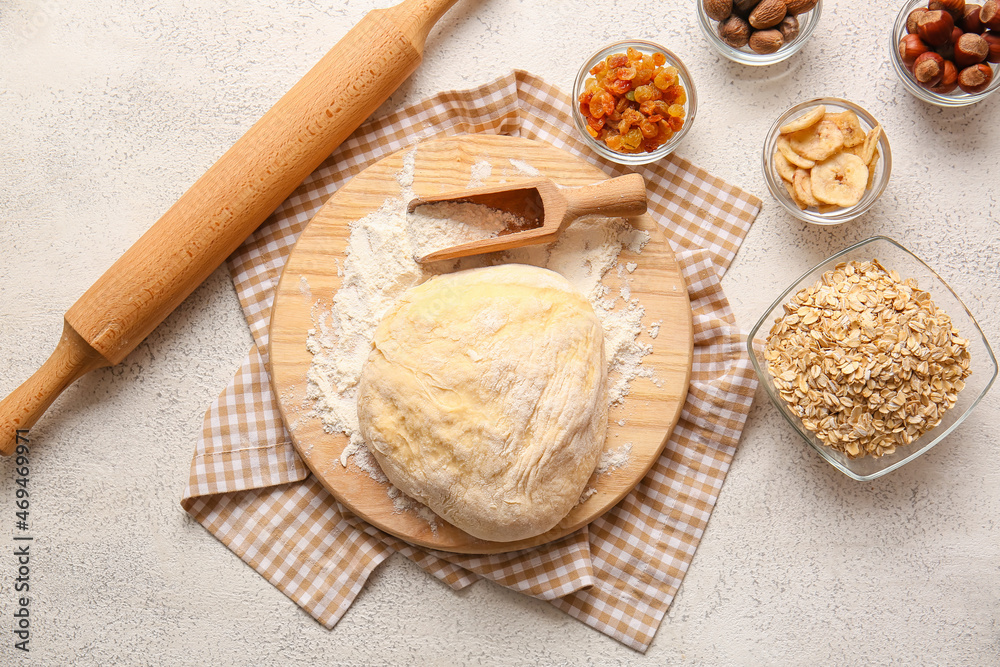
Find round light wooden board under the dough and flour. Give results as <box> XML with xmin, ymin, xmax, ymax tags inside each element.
<box><xmin>269</xmin><ymin>135</ymin><xmax>693</xmax><ymax>553</ymax></box>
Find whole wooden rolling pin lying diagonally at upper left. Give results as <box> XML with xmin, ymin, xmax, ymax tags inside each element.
<box><xmin>0</xmin><ymin>0</ymin><xmax>455</xmax><ymax>455</ymax></box>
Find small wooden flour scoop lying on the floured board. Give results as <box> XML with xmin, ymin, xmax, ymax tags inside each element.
<box><xmin>407</xmin><ymin>174</ymin><xmax>646</xmax><ymax>264</ymax></box>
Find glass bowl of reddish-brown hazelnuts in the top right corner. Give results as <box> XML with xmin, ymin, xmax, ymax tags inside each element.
<box><xmin>890</xmin><ymin>0</ymin><xmax>1000</xmax><ymax>107</ymax></box>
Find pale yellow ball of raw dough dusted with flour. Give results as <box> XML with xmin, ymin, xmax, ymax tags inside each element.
<box><xmin>358</xmin><ymin>264</ymin><xmax>608</xmax><ymax>542</ymax></box>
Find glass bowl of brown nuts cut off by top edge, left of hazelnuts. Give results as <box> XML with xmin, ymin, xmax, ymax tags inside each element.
<box><xmin>695</xmin><ymin>0</ymin><xmax>823</xmax><ymax>65</ymax></box>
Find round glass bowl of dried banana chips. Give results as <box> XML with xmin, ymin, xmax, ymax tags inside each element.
<box><xmin>761</xmin><ymin>97</ymin><xmax>892</xmax><ymax>225</ymax></box>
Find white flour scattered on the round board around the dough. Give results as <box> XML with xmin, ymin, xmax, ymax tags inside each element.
<box><xmin>308</xmin><ymin>150</ymin><xmax>655</xmax><ymax>520</ymax></box>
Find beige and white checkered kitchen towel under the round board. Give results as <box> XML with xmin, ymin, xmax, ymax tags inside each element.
<box><xmin>182</xmin><ymin>71</ymin><xmax>760</xmax><ymax>651</ymax></box>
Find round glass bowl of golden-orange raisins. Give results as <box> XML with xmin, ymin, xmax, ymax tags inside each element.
<box><xmin>573</xmin><ymin>39</ymin><xmax>698</xmax><ymax>165</ymax></box>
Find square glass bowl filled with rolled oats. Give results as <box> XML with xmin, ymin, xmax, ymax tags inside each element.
<box><xmin>747</xmin><ymin>236</ymin><xmax>997</xmax><ymax>481</ymax></box>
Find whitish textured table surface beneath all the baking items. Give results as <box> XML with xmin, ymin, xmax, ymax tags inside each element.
<box><xmin>0</xmin><ymin>0</ymin><xmax>1000</xmax><ymax>665</ymax></box>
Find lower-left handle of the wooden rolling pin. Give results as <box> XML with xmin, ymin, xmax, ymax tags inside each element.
<box><xmin>0</xmin><ymin>322</ymin><xmax>111</xmax><ymax>456</ymax></box>
